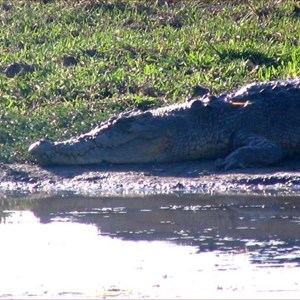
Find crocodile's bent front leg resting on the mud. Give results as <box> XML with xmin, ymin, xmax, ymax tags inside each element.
<box><xmin>215</xmin><ymin>130</ymin><xmax>283</xmax><ymax>170</ymax></box>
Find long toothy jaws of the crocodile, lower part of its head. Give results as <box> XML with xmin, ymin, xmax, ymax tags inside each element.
<box><xmin>28</xmin><ymin>138</ymin><xmax>169</xmax><ymax>165</ymax></box>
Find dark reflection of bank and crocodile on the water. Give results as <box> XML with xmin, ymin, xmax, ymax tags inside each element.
<box><xmin>0</xmin><ymin>195</ymin><xmax>300</xmax><ymax>264</ymax></box>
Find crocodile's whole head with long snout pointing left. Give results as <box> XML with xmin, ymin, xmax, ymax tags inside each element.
<box><xmin>28</xmin><ymin>111</ymin><xmax>171</xmax><ymax>165</ymax></box>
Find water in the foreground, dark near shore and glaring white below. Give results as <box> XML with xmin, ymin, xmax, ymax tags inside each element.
<box><xmin>0</xmin><ymin>194</ymin><xmax>300</xmax><ymax>299</ymax></box>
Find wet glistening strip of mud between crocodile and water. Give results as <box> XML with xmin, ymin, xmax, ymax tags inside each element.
<box><xmin>0</xmin><ymin>160</ymin><xmax>300</xmax><ymax>196</ymax></box>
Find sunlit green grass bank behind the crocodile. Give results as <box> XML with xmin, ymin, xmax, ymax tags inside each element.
<box><xmin>0</xmin><ymin>0</ymin><xmax>300</xmax><ymax>162</ymax></box>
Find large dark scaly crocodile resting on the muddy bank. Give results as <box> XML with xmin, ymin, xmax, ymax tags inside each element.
<box><xmin>29</xmin><ymin>79</ymin><xmax>300</xmax><ymax>169</ymax></box>
